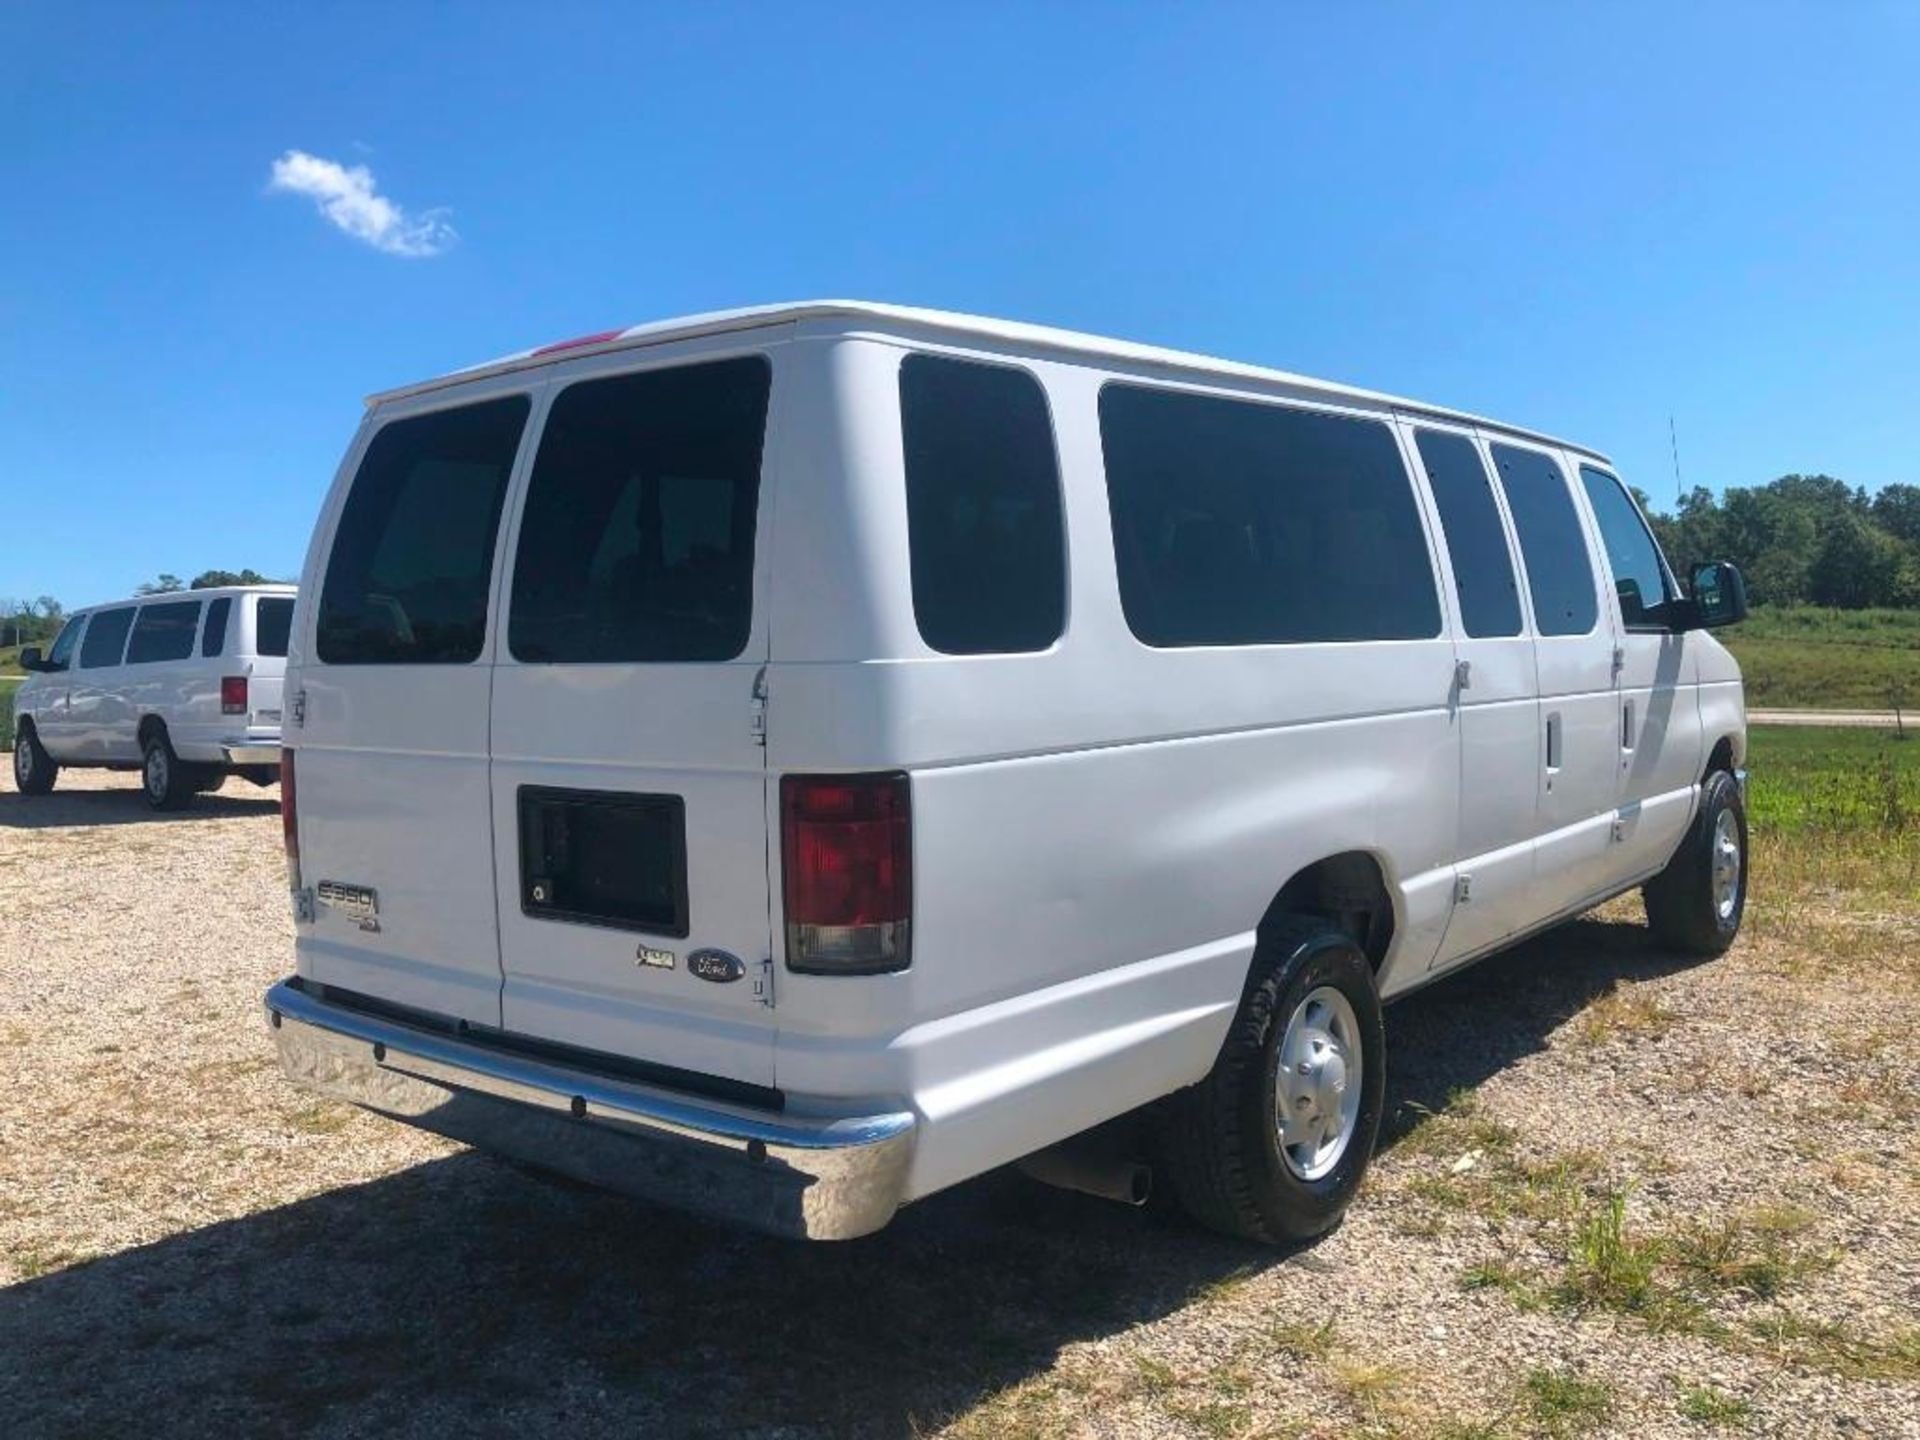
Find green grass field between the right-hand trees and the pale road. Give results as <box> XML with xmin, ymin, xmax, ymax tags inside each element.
<box><xmin>1718</xmin><ymin>605</ymin><xmax>1920</xmax><ymax>710</ymax></box>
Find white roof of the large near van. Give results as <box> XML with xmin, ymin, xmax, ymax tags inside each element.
<box><xmin>367</xmin><ymin>300</ymin><xmax>1607</xmax><ymax>461</ymax></box>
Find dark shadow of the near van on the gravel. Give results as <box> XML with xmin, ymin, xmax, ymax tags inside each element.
<box><xmin>0</xmin><ymin>917</ymin><xmax>1712</xmax><ymax>1440</ymax></box>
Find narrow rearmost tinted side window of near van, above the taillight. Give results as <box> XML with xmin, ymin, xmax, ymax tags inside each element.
<box><xmin>900</xmin><ymin>355</ymin><xmax>1068</xmax><ymax>655</ymax></box>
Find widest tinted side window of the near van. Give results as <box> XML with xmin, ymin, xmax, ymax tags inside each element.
<box><xmin>1100</xmin><ymin>384</ymin><xmax>1440</xmax><ymax>645</ymax></box>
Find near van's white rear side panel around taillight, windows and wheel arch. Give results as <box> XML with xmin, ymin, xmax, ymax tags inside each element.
<box><xmin>768</xmin><ymin>344</ymin><xmax>1459</xmax><ymax>1194</ymax></box>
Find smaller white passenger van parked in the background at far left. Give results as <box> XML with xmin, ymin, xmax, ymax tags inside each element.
<box><xmin>13</xmin><ymin>586</ymin><xmax>296</xmax><ymax>810</ymax></box>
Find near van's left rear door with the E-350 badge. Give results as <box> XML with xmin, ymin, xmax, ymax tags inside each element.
<box><xmin>284</xmin><ymin>380</ymin><xmax>536</xmax><ymax>1025</ymax></box>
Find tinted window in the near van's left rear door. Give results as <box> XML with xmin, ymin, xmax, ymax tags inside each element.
<box><xmin>315</xmin><ymin>396</ymin><xmax>528</xmax><ymax>664</ymax></box>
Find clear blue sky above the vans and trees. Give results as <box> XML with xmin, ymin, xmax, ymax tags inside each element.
<box><xmin>0</xmin><ymin>0</ymin><xmax>1920</xmax><ymax>605</ymax></box>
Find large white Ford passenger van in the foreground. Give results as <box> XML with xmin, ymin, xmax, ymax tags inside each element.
<box><xmin>267</xmin><ymin>303</ymin><xmax>1745</xmax><ymax>1242</ymax></box>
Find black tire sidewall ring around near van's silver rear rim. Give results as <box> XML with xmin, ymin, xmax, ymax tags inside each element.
<box><xmin>1240</xmin><ymin>931</ymin><xmax>1386</xmax><ymax>1240</ymax></box>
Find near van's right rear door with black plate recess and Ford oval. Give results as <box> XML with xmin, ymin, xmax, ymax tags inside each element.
<box><xmin>493</xmin><ymin>338</ymin><xmax>776</xmax><ymax>1085</ymax></box>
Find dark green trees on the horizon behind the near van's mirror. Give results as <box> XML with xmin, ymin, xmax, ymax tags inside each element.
<box><xmin>1642</xmin><ymin>474</ymin><xmax>1920</xmax><ymax>611</ymax></box>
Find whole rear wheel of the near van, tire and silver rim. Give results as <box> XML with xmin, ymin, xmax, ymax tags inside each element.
<box><xmin>1154</xmin><ymin>916</ymin><xmax>1386</xmax><ymax>1244</ymax></box>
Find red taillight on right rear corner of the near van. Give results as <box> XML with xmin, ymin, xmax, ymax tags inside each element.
<box><xmin>780</xmin><ymin>774</ymin><xmax>914</xmax><ymax>975</ymax></box>
